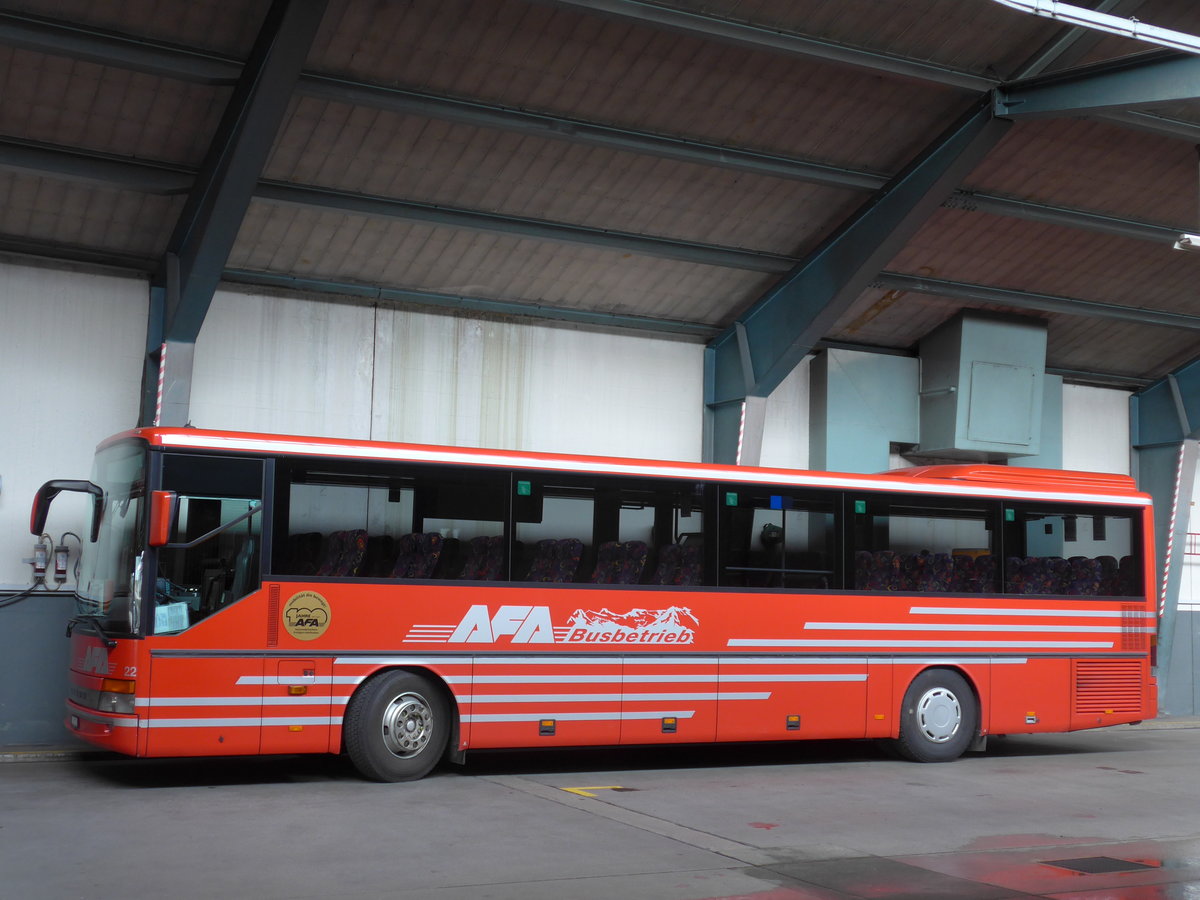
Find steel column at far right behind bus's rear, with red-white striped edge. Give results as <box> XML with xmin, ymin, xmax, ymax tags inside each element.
<box><xmin>1129</xmin><ymin>359</ymin><xmax>1200</xmax><ymax>715</ymax></box>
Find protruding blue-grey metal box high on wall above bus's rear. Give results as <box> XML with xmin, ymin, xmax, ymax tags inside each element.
<box><xmin>912</xmin><ymin>311</ymin><xmax>1046</xmax><ymax>461</ymax></box>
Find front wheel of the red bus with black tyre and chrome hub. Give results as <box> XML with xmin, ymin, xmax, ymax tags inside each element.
<box><xmin>343</xmin><ymin>670</ymin><xmax>450</xmax><ymax>781</ymax></box>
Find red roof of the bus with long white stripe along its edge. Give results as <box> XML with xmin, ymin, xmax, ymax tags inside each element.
<box><xmin>108</xmin><ymin>427</ymin><xmax>1150</xmax><ymax>506</ymax></box>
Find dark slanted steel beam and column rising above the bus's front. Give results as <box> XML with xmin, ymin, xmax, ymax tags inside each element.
<box><xmin>140</xmin><ymin>0</ymin><xmax>325</xmax><ymax>425</ymax></box>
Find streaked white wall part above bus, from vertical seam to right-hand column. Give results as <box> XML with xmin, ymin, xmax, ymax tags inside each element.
<box><xmin>372</xmin><ymin>304</ymin><xmax>703</xmax><ymax>461</ymax></box>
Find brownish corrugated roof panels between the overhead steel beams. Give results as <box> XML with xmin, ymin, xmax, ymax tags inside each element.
<box><xmin>0</xmin><ymin>0</ymin><xmax>1200</xmax><ymax>386</ymax></box>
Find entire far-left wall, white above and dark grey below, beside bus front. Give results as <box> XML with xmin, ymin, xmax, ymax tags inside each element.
<box><xmin>0</xmin><ymin>262</ymin><xmax>146</xmax><ymax>748</ymax></box>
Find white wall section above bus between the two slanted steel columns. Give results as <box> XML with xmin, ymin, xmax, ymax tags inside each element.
<box><xmin>191</xmin><ymin>290</ymin><xmax>703</xmax><ymax>460</ymax></box>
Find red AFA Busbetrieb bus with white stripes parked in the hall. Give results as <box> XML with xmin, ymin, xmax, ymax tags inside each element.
<box><xmin>31</xmin><ymin>428</ymin><xmax>1157</xmax><ymax>781</ymax></box>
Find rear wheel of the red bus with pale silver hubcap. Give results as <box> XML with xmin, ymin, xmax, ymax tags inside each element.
<box><xmin>894</xmin><ymin>668</ymin><xmax>979</xmax><ymax>762</ymax></box>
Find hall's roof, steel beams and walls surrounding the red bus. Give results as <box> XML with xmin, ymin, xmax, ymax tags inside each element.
<box><xmin>0</xmin><ymin>0</ymin><xmax>1200</xmax><ymax>746</ymax></box>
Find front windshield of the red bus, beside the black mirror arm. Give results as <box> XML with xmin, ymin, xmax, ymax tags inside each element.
<box><xmin>77</xmin><ymin>440</ymin><xmax>146</xmax><ymax>636</ymax></box>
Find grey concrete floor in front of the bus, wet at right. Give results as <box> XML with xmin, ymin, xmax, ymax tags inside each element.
<box><xmin>0</xmin><ymin>719</ymin><xmax>1200</xmax><ymax>900</ymax></box>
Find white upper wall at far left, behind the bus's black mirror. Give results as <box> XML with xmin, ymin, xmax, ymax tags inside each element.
<box><xmin>0</xmin><ymin>256</ymin><xmax>148</xmax><ymax>586</ymax></box>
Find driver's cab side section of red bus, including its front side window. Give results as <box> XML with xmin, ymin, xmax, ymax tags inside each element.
<box><xmin>138</xmin><ymin>454</ymin><xmax>267</xmax><ymax>756</ymax></box>
